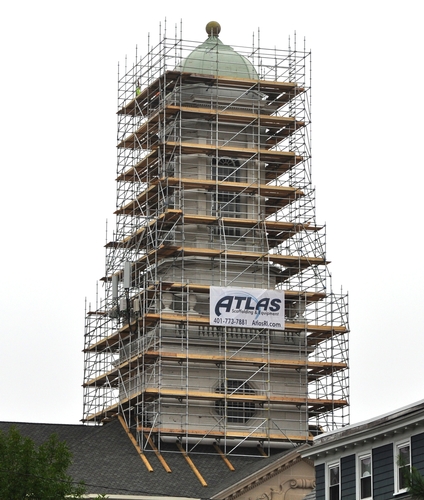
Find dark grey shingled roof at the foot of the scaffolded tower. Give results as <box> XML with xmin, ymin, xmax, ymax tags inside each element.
<box><xmin>0</xmin><ymin>420</ymin><xmax>303</xmax><ymax>499</ymax></box>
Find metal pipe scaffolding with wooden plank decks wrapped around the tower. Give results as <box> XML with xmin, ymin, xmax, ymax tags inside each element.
<box><xmin>83</xmin><ymin>25</ymin><xmax>349</xmax><ymax>454</ymax></box>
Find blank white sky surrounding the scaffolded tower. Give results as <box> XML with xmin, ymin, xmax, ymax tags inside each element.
<box><xmin>0</xmin><ymin>0</ymin><xmax>424</xmax><ymax>423</ymax></box>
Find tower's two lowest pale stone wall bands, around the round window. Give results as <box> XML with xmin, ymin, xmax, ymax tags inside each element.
<box><xmin>122</xmin><ymin>360</ymin><xmax>308</xmax><ymax>438</ymax></box>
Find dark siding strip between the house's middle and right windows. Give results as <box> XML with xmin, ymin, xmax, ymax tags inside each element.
<box><xmin>372</xmin><ymin>443</ymin><xmax>394</xmax><ymax>500</ymax></box>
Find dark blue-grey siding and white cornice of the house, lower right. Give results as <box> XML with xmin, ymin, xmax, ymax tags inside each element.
<box><xmin>302</xmin><ymin>399</ymin><xmax>424</xmax><ymax>500</ymax></box>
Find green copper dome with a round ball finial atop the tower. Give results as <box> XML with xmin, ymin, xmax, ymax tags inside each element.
<box><xmin>181</xmin><ymin>21</ymin><xmax>258</xmax><ymax>79</ymax></box>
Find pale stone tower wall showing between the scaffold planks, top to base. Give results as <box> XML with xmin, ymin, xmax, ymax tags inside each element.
<box><xmin>121</xmin><ymin>76</ymin><xmax>309</xmax><ymax>439</ymax></box>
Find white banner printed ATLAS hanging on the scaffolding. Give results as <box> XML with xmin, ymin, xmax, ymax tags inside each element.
<box><xmin>209</xmin><ymin>286</ymin><xmax>284</xmax><ymax>330</ymax></box>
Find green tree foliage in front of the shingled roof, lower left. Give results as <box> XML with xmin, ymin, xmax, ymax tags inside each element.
<box><xmin>0</xmin><ymin>427</ymin><xmax>85</xmax><ymax>500</ymax></box>
